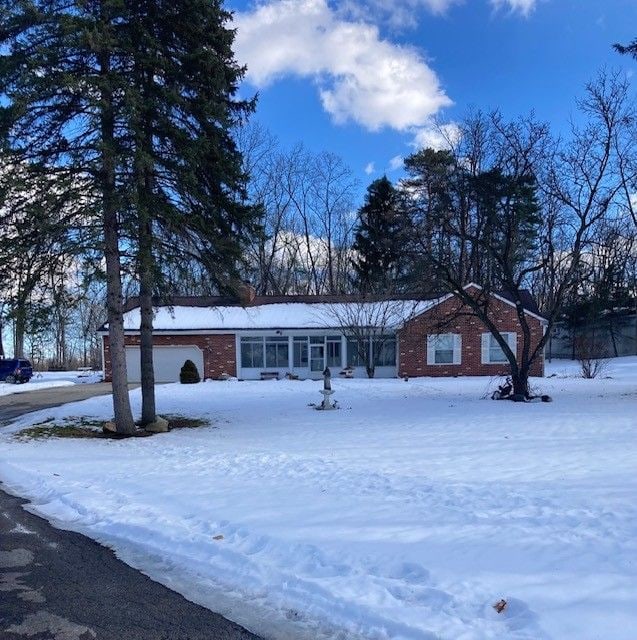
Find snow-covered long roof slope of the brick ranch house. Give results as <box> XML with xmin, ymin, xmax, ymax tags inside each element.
<box><xmin>124</xmin><ymin>300</ymin><xmax>437</xmax><ymax>331</ymax></box>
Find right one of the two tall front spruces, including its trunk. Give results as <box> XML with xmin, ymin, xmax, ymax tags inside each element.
<box><xmin>122</xmin><ymin>0</ymin><xmax>255</xmax><ymax>423</ymax></box>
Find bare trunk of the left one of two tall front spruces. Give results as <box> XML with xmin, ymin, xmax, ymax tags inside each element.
<box><xmin>99</xmin><ymin>45</ymin><xmax>135</xmax><ymax>435</ymax></box>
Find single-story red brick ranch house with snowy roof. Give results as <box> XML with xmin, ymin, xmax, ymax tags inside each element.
<box><xmin>100</xmin><ymin>284</ymin><xmax>546</xmax><ymax>382</ymax></box>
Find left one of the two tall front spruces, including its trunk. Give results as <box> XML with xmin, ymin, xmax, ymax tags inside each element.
<box><xmin>0</xmin><ymin>0</ymin><xmax>135</xmax><ymax>434</ymax></box>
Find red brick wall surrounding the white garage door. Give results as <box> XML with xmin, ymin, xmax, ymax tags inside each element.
<box><xmin>104</xmin><ymin>334</ymin><xmax>237</xmax><ymax>381</ymax></box>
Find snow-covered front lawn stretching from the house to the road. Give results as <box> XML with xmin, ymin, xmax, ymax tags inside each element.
<box><xmin>0</xmin><ymin>358</ymin><xmax>637</xmax><ymax>640</ymax></box>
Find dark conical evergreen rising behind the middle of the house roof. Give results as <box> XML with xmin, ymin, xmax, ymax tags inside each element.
<box><xmin>352</xmin><ymin>176</ymin><xmax>404</xmax><ymax>294</ymax></box>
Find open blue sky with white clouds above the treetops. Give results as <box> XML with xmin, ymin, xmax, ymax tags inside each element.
<box><xmin>228</xmin><ymin>0</ymin><xmax>637</xmax><ymax>185</ymax></box>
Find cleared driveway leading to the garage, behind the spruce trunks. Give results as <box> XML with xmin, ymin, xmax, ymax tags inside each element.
<box><xmin>0</xmin><ymin>382</ymin><xmax>131</xmax><ymax>423</ymax></box>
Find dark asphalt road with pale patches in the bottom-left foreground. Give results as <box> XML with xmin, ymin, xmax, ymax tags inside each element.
<box><xmin>0</xmin><ymin>491</ymin><xmax>258</xmax><ymax>640</ymax></box>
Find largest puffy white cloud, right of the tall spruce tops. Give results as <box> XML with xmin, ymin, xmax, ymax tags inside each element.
<box><xmin>235</xmin><ymin>0</ymin><xmax>451</xmax><ymax>131</ymax></box>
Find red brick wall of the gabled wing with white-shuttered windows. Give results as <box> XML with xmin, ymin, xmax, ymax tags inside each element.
<box><xmin>398</xmin><ymin>298</ymin><xmax>544</xmax><ymax>376</ymax></box>
